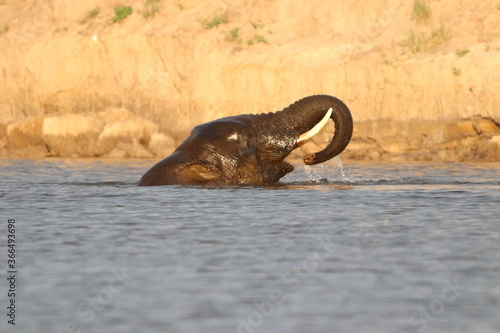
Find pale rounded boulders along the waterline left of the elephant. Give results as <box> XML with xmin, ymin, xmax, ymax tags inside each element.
<box><xmin>0</xmin><ymin>108</ymin><xmax>174</xmax><ymax>158</ymax></box>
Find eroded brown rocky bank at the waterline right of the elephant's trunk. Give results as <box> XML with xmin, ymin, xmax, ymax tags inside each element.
<box><xmin>338</xmin><ymin>117</ymin><xmax>500</xmax><ymax>162</ymax></box>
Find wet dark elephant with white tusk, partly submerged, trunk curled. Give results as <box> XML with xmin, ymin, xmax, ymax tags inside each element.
<box><xmin>138</xmin><ymin>95</ymin><xmax>353</xmax><ymax>186</ymax></box>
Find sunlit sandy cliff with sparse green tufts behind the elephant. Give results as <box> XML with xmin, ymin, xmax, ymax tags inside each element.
<box><xmin>0</xmin><ymin>0</ymin><xmax>500</xmax><ymax>161</ymax></box>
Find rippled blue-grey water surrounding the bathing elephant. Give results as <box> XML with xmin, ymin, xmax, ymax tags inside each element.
<box><xmin>0</xmin><ymin>159</ymin><xmax>500</xmax><ymax>333</ymax></box>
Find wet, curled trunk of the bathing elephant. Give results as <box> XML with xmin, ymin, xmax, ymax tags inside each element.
<box><xmin>275</xmin><ymin>95</ymin><xmax>353</xmax><ymax>165</ymax></box>
